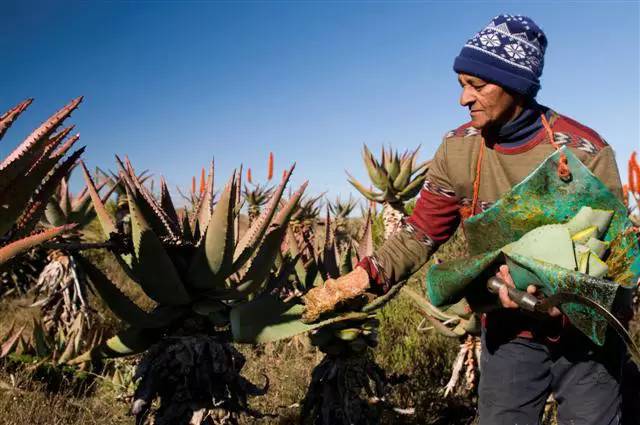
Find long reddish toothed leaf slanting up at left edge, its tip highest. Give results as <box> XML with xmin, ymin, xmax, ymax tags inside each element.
<box><xmin>0</xmin><ymin>97</ymin><xmax>82</xmax><ymax>188</ymax></box>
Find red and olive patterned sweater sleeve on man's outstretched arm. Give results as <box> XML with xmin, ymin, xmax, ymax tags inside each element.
<box><xmin>359</xmin><ymin>142</ymin><xmax>460</xmax><ymax>292</ymax></box>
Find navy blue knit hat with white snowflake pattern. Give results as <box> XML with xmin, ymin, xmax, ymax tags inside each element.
<box><xmin>453</xmin><ymin>15</ymin><xmax>547</xmax><ymax>98</ymax></box>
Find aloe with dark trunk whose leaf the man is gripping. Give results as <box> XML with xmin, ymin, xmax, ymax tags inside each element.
<box><xmin>231</xmin><ymin>209</ymin><xmax>408</xmax><ymax>425</ymax></box>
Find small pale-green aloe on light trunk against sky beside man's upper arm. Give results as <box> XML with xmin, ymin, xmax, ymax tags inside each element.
<box><xmin>347</xmin><ymin>145</ymin><xmax>430</xmax><ymax>239</ymax></box>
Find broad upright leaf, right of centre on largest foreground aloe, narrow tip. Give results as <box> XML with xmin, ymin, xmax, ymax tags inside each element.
<box><xmin>189</xmin><ymin>172</ymin><xmax>236</xmax><ymax>289</ymax></box>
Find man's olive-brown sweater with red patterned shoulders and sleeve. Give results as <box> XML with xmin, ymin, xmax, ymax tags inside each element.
<box><xmin>360</xmin><ymin>108</ymin><xmax>622</xmax><ymax>292</ymax></box>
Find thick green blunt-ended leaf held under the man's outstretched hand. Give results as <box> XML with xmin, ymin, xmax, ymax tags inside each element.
<box><xmin>230</xmin><ymin>294</ymin><xmax>369</xmax><ymax>344</ymax></box>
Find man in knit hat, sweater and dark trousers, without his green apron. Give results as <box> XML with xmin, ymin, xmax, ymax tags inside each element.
<box><xmin>305</xmin><ymin>15</ymin><xmax>622</xmax><ymax>425</ymax></box>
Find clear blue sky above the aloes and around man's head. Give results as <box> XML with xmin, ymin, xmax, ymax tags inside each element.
<box><xmin>0</xmin><ymin>1</ymin><xmax>640</xmax><ymax>205</ymax></box>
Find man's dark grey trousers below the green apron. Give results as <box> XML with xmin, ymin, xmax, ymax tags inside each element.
<box><xmin>478</xmin><ymin>314</ymin><xmax>624</xmax><ymax>425</ymax></box>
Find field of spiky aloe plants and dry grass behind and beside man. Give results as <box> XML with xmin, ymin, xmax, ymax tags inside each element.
<box><xmin>0</xmin><ymin>98</ymin><xmax>640</xmax><ymax>425</ymax></box>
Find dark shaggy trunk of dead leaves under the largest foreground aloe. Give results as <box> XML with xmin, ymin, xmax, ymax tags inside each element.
<box><xmin>132</xmin><ymin>335</ymin><xmax>264</xmax><ymax>425</ymax></box>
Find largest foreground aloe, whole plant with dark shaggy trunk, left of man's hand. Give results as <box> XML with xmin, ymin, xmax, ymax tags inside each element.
<box><xmin>72</xmin><ymin>161</ymin><xmax>306</xmax><ymax>424</ymax></box>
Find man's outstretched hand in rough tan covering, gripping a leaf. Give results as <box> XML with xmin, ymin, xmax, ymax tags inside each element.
<box><xmin>302</xmin><ymin>267</ymin><xmax>369</xmax><ymax>322</ymax></box>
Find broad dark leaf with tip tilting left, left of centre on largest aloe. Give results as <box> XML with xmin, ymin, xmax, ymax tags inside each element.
<box><xmin>127</xmin><ymin>188</ymin><xmax>190</xmax><ymax>305</ymax></box>
